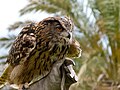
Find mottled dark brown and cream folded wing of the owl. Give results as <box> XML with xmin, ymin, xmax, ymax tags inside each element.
<box><xmin>7</xmin><ymin>24</ymin><xmax>36</xmax><ymax>66</ymax></box>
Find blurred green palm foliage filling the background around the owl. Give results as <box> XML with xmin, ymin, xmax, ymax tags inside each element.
<box><xmin>0</xmin><ymin>0</ymin><xmax>120</xmax><ymax>90</ymax></box>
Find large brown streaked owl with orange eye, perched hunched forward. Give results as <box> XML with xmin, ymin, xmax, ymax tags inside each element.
<box><xmin>0</xmin><ymin>17</ymin><xmax>81</xmax><ymax>89</ymax></box>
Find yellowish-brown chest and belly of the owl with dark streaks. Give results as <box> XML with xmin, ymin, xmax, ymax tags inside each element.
<box><xmin>15</xmin><ymin>44</ymin><xmax>68</xmax><ymax>82</ymax></box>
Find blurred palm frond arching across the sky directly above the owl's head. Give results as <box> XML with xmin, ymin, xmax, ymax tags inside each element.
<box><xmin>20</xmin><ymin>0</ymin><xmax>71</xmax><ymax>15</ymax></box>
